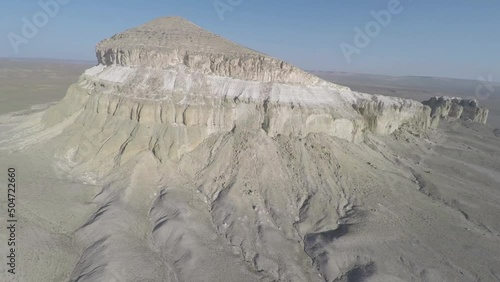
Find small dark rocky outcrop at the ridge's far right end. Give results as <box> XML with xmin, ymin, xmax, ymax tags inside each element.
<box><xmin>422</xmin><ymin>97</ymin><xmax>488</xmax><ymax>124</ymax></box>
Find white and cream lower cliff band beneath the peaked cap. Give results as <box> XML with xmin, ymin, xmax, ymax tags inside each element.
<box><xmin>43</xmin><ymin>69</ymin><xmax>428</xmax><ymax>174</ymax></box>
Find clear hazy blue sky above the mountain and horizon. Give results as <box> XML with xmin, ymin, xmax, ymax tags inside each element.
<box><xmin>0</xmin><ymin>0</ymin><xmax>500</xmax><ymax>81</ymax></box>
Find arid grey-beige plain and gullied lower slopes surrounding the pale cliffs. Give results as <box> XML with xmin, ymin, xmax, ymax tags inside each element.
<box><xmin>0</xmin><ymin>60</ymin><xmax>500</xmax><ymax>282</ymax></box>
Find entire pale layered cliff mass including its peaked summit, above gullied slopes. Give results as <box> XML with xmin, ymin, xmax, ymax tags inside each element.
<box><xmin>39</xmin><ymin>17</ymin><xmax>446</xmax><ymax>176</ymax></box>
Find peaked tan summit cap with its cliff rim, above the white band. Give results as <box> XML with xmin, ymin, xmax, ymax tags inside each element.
<box><xmin>96</xmin><ymin>17</ymin><xmax>326</xmax><ymax>85</ymax></box>
